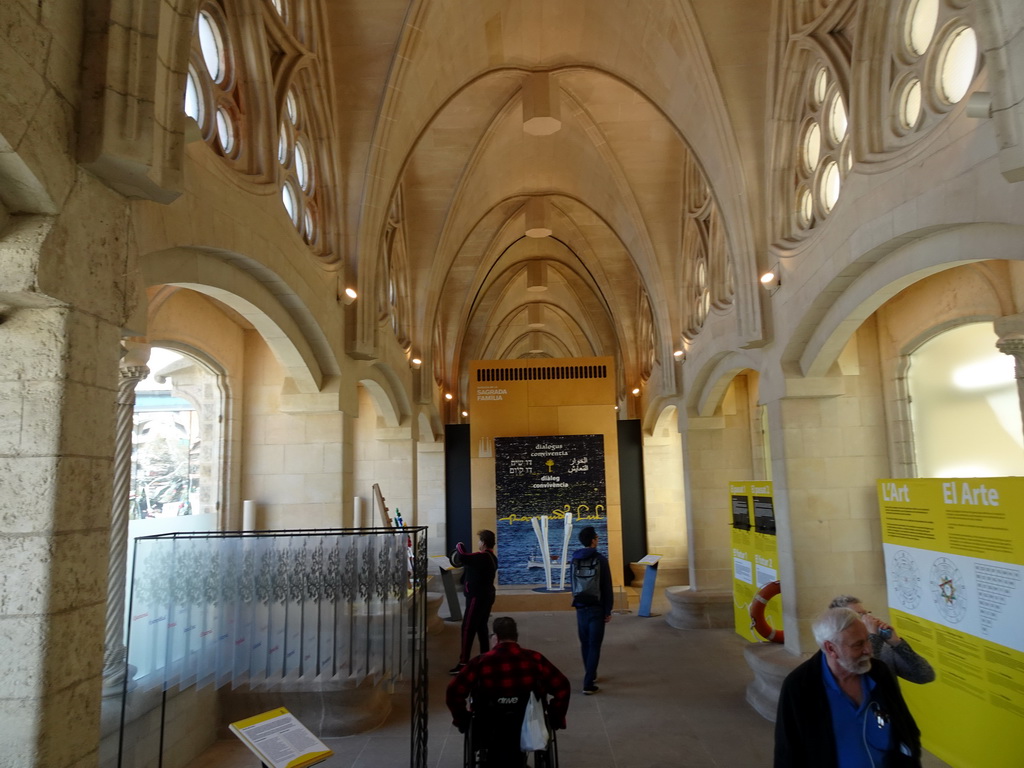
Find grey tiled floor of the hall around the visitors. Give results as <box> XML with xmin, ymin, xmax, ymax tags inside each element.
<box><xmin>189</xmin><ymin>593</ymin><xmax>946</xmax><ymax>768</ymax></box>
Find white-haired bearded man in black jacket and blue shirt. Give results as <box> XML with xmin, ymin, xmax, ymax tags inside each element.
<box><xmin>775</xmin><ymin>608</ymin><xmax>921</xmax><ymax>768</ymax></box>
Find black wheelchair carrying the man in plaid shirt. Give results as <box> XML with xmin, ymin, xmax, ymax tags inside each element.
<box><xmin>463</xmin><ymin>691</ymin><xmax>558</xmax><ymax>768</ymax></box>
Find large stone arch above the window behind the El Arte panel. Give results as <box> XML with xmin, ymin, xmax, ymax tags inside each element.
<box><xmin>792</xmin><ymin>224</ymin><xmax>1024</xmax><ymax>376</ymax></box>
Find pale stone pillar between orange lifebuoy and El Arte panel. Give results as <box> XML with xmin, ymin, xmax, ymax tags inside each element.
<box><xmin>764</xmin><ymin>358</ymin><xmax>889</xmax><ymax>653</ymax></box>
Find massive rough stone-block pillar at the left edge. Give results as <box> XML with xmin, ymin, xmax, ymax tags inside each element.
<box><xmin>0</xmin><ymin>298</ymin><xmax>119</xmax><ymax>768</ymax></box>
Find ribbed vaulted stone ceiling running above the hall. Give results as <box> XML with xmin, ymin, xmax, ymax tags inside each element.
<box><xmin>327</xmin><ymin>0</ymin><xmax>771</xmax><ymax>403</ymax></box>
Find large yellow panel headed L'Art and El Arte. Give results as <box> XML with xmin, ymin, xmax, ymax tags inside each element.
<box><xmin>878</xmin><ymin>477</ymin><xmax>1024</xmax><ymax>768</ymax></box>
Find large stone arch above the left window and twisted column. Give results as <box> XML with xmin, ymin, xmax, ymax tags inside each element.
<box><xmin>140</xmin><ymin>248</ymin><xmax>327</xmax><ymax>394</ymax></box>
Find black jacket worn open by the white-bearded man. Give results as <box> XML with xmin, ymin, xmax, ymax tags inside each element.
<box><xmin>775</xmin><ymin>650</ymin><xmax>921</xmax><ymax>768</ymax></box>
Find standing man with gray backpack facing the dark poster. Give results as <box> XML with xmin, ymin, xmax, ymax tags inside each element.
<box><xmin>571</xmin><ymin>525</ymin><xmax>614</xmax><ymax>696</ymax></box>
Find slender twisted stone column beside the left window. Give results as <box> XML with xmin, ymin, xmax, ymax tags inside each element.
<box><xmin>103</xmin><ymin>342</ymin><xmax>150</xmax><ymax>696</ymax></box>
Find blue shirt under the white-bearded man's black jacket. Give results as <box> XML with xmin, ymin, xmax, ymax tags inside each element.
<box><xmin>821</xmin><ymin>654</ymin><xmax>892</xmax><ymax>768</ymax></box>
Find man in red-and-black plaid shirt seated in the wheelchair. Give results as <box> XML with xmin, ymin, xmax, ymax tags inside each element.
<box><xmin>445</xmin><ymin>616</ymin><xmax>569</xmax><ymax>742</ymax></box>
